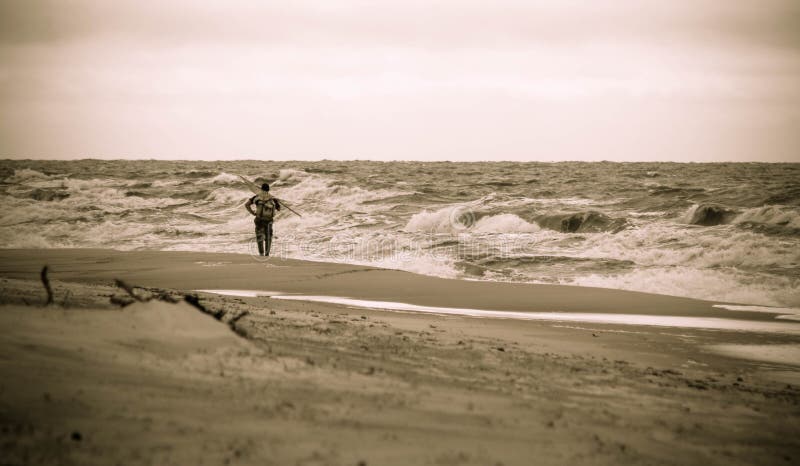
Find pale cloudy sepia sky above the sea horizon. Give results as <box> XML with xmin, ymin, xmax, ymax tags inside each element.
<box><xmin>0</xmin><ymin>0</ymin><xmax>800</xmax><ymax>162</ymax></box>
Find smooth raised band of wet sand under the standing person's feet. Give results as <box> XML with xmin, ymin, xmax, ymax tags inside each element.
<box><xmin>0</xmin><ymin>249</ymin><xmax>788</xmax><ymax>321</ymax></box>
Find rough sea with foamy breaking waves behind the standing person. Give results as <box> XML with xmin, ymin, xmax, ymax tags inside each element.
<box><xmin>0</xmin><ymin>160</ymin><xmax>800</xmax><ymax>307</ymax></box>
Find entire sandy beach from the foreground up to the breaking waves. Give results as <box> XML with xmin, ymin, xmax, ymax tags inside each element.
<box><xmin>0</xmin><ymin>250</ymin><xmax>800</xmax><ymax>465</ymax></box>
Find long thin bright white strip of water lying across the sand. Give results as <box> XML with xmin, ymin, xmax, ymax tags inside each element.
<box><xmin>270</xmin><ymin>294</ymin><xmax>800</xmax><ymax>335</ymax></box>
